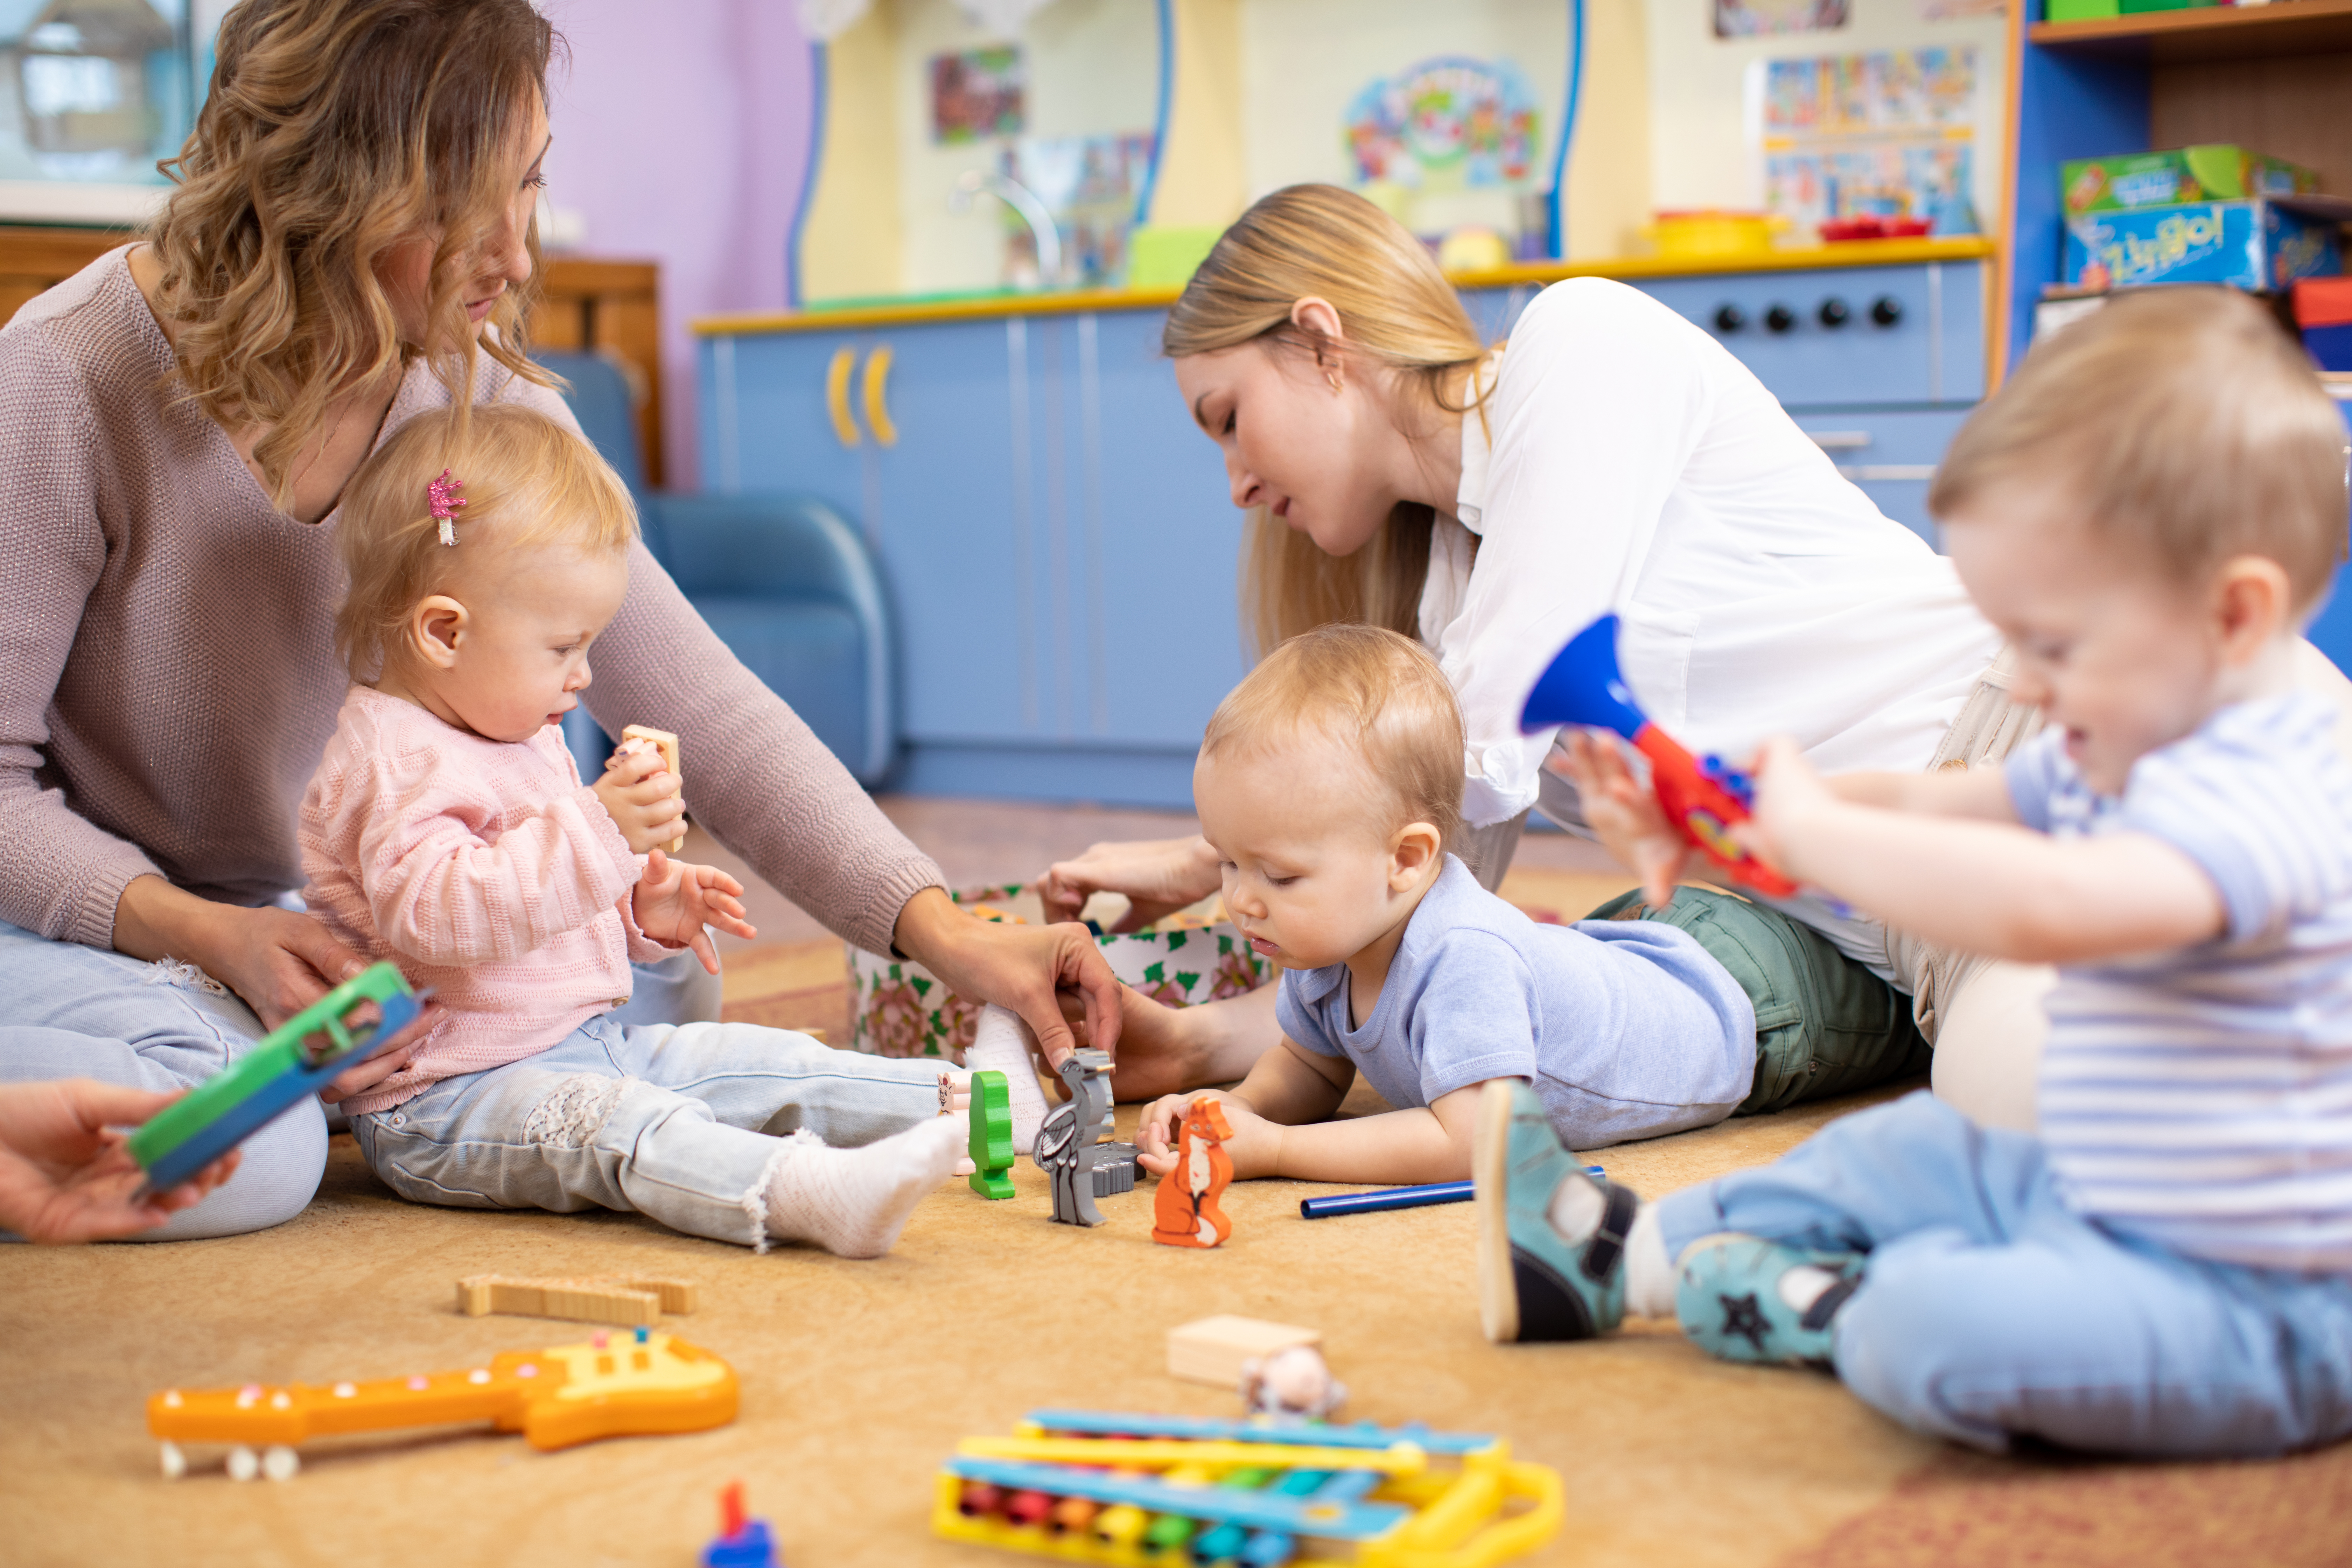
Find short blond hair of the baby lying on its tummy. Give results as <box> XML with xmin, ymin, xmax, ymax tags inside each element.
<box><xmin>1199</xmin><ymin>621</ymin><xmax>1463</xmax><ymax>849</ymax></box>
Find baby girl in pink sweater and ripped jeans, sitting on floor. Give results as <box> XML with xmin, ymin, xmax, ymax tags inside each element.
<box><xmin>301</xmin><ymin>404</ymin><xmax>964</xmax><ymax>1258</ymax></box>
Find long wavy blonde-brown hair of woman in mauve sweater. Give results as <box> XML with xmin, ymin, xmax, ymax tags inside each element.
<box><xmin>146</xmin><ymin>0</ymin><xmax>560</xmax><ymax>505</ymax></box>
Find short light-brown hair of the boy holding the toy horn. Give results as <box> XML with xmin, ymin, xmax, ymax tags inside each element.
<box><xmin>1926</xmin><ymin>285</ymin><xmax>2347</xmax><ymax>614</ymax></box>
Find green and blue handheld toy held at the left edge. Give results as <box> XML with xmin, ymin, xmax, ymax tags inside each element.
<box><xmin>127</xmin><ymin>964</ymin><xmax>424</xmax><ymax>1192</ymax></box>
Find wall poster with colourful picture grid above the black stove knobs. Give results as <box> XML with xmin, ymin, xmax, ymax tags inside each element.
<box><xmin>1757</xmin><ymin>49</ymin><xmax>1978</xmax><ymax>233</ymax></box>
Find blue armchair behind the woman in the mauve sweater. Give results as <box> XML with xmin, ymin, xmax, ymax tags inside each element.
<box><xmin>539</xmin><ymin>350</ymin><xmax>898</xmax><ymax>788</ymax></box>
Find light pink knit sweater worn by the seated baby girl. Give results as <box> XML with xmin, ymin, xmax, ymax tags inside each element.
<box><xmin>299</xmin><ymin>686</ymin><xmax>675</xmax><ymax>1116</ymax></box>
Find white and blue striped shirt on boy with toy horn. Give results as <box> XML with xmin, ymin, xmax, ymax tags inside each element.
<box><xmin>2009</xmin><ymin>693</ymin><xmax>2352</xmax><ymax>1272</ymax></box>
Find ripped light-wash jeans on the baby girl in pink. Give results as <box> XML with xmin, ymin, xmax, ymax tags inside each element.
<box><xmin>350</xmin><ymin>1013</ymin><xmax>948</xmax><ymax>1246</ymax></box>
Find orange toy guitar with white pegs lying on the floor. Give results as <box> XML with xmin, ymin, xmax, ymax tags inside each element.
<box><xmin>148</xmin><ymin>1328</ymin><xmax>736</xmax><ymax>1481</ymax></box>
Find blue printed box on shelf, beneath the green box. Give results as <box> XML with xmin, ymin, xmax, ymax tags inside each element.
<box><xmin>2065</xmin><ymin>195</ymin><xmax>2352</xmax><ymax>292</ymax></box>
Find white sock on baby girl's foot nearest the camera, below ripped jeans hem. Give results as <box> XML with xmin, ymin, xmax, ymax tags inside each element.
<box><xmin>762</xmin><ymin>1116</ymin><xmax>969</xmax><ymax>1258</ymax></box>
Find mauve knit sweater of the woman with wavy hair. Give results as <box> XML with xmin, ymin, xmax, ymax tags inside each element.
<box><xmin>0</xmin><ymin>249</ymin><xmax>938</xmax><ymax>964</ymax></box>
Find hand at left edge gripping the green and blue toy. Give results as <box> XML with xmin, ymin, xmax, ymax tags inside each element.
<box><xmin>0</xmin><ymin>1079</ymin><xmax>238</xmax><ymax>1241</ymax></box>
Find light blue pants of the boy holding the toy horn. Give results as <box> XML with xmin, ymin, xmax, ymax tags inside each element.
<box><xmin>1658</xmin><ymin>1091</ymin><xmax>2352</xmax><ymax>1455</ymax></box>
